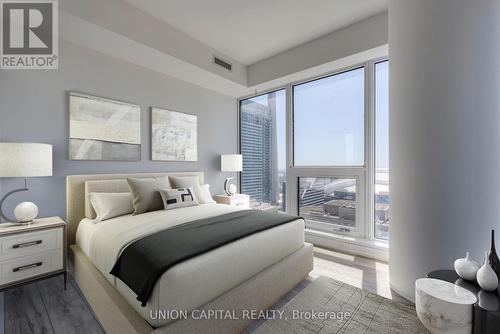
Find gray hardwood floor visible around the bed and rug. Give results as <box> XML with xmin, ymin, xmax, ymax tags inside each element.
<box><xmin>4</xmin><ymin>247</ymin><xmax>405</xmax><ymax>334</ymax></box>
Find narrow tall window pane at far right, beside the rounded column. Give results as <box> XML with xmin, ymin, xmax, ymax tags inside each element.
<box><xmin>374</xmin><ymin>61</ymin><xmax>389</xmax><ymax>240</ymax></box>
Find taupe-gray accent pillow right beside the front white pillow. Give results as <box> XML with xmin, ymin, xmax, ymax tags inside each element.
<box><xmin>127</xmin><ymin>177</ymin><xmax>163</xmax><ymax>215</ymax></box>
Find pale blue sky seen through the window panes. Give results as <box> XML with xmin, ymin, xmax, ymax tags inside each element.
<box><xmin>244</xmin><ymin>61</ymin><xmax>389</xmax><ymax>170</ymax></box>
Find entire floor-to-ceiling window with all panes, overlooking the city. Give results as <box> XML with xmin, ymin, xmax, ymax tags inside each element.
<box><xmin>240</xmin><ymin>60</ymin><xmax>389</xmax><ymax>243</ymax></box>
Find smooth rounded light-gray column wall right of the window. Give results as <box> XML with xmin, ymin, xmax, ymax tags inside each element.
<box><xmin>389</xmin><ymin>0</ymin><xmax>500</xmax><ymax>299</ymax></box>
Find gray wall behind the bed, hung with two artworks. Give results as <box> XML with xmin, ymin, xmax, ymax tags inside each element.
<box><xmin>0</xmin><ymin>41</ymin><xmax>237</xmax><ymax>217</ymax></box>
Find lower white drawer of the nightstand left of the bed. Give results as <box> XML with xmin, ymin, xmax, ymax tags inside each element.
<box><xmin>0</xmin><ymin>249</ymin><xmax>63</xmax><ymax>285</ymax></box>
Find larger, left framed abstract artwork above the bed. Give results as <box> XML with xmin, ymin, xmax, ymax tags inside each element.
<box><xmin>69</xmin><ymin>92</ymin><xmax>141</xmax><ymax>161</ymax></box>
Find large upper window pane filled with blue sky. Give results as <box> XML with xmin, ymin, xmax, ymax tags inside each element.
<box><xmin>293</xmin><ymin>68</ymin><xmax>365</xmax><ymax>166</ymax></box>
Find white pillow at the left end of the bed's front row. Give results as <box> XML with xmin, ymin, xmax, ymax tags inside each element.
<box><xmin>89</xmin><ymin>193</ymin><xmax>134</xmax><ymax>223</ymax></box>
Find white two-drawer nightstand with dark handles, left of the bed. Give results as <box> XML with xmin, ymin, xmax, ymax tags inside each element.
<box><xmin>0</xmin><ymin>217</ymin><xmax>67</xmax><ymax>291</ymax></box>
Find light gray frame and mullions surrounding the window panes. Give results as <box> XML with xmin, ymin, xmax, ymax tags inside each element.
<box><xmin>236</xmin><ymin>56</ymin><xmax>389</xmax><ymax>244</ymax></box>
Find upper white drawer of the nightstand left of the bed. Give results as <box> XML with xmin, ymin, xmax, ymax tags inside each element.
<box><xmin>0</xmin><ymin>227</ymin><xmax>63</xmax><ymax>261</ymax></box>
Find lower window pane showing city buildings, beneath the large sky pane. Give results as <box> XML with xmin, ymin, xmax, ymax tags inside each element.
<box><xmin>298</xmin><ymin>177</ymin><xmax>356</xmax><ymax>232</ymax></box>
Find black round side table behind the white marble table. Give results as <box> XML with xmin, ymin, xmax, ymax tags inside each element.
<box><xmin>427</xmin><ymin>270</ymin><xmax>500</xmax><ymax>334</ymax></box>
